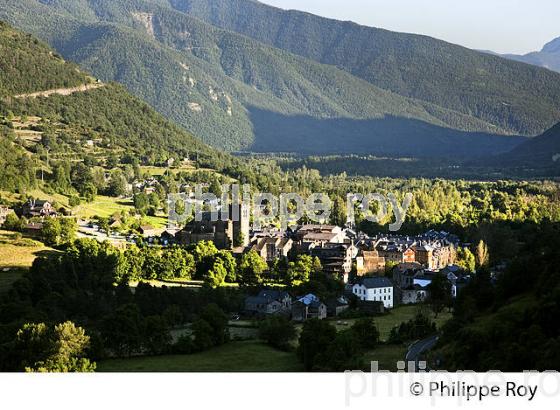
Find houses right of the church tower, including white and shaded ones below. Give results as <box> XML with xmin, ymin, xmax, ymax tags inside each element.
<box><xmin>241</xmin><ymin>225</ymin><xmax>470</xmax><ymax>321</ymax></box>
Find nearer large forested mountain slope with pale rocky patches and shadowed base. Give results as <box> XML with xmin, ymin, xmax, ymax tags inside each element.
<box><xmin>0</xmin><ymin>0</ymin><xmax>536</xmax><ymax>156</ymax></box>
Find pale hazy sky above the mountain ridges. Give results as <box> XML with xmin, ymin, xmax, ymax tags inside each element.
<box><xmin>260</xmin><ymin>0</ymin><xmax>560</xmax><ymax>54</ymax></box>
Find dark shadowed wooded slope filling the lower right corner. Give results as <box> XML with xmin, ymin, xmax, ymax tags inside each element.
<box><xmin>432</xmin><ymin>223</ymin><xmax>560</xmax><ymax>372</ymax></box>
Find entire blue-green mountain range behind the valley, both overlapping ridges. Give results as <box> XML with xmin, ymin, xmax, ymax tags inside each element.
<box><xmin>0</xmin><ymin>0</ymin><xmax>560</xmax><ymax>157</ymax></box>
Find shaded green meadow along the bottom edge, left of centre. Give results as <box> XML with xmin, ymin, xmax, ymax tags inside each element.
<box><xmin>97</xmin><ymin>341</ymin><xmax>302</xmax><ymax>372</ymax></box>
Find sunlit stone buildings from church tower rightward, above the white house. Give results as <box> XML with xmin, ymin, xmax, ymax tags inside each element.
<box><xmin>165</xmin><ymin>210</ymin><xmax>459</xmax><ymax>283</ymax></box>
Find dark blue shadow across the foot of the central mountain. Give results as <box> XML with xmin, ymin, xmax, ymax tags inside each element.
<box><xmin>248</xmin><ymin>107</ymin><xmax>526</xmax><ymax>158</ymax></box>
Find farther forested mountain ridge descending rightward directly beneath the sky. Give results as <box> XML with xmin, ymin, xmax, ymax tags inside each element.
<box><xmin>160</xmin><ymin>0</ymin><xmax>560</xmax><ymax>135</ymax></box>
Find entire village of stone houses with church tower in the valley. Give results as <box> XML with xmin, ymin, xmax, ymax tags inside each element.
<box><xmin>0</xmin><ymin>189</ymin><xmax>471</xmax><ymax>321</ymax></box>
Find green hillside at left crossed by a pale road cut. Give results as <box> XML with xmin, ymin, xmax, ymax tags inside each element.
<box><xmin>0</xmin><ymin>23</ymin><xmax>241</xmax><ymax>191</ymax></box>
